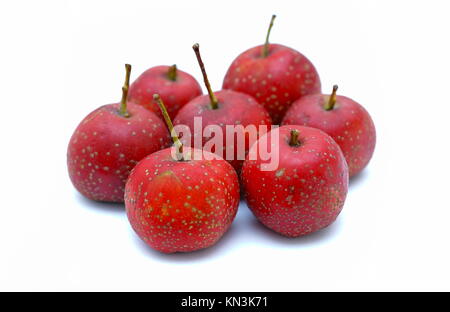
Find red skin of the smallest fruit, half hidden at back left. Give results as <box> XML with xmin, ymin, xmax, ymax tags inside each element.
<box><xmin>128</xmin><ymin>66</ymin><xmax>202</xmax><ymax>119</ymax></box>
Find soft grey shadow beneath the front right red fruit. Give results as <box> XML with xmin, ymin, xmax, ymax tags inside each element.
<box><xmin>247</xmin><ymin>213</ymin><xmax>341</xmax><ymax>246</ymax></box>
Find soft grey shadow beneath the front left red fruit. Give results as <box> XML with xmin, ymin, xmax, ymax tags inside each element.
<box><xmin>130</xmin><ymin>223</ymin><xmax>243</xmax><ymax>263</ymax></box>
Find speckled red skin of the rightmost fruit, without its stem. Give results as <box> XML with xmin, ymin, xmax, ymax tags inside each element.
<box><xmin>282</xmin><ymin>94</ymin><xmax>376</xmax><ymax>177</ymax></box>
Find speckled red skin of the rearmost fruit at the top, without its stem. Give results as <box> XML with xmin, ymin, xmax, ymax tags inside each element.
<box><xmin>223</xmin><ymin>44</ymin><xmax>321</xmax><ymax>124</ymax></box>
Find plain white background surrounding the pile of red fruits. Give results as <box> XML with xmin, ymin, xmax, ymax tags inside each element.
<box><xmin>0</xmin><ymin>0</ymin><xmax>450</xmax><ymax>291</ymax></box>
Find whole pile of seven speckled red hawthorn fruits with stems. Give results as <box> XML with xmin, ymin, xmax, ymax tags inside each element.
<box><xmin>67</xmin><ymin>16</ymin><xmax>375</xmax><ymax>253</ymax></box>
